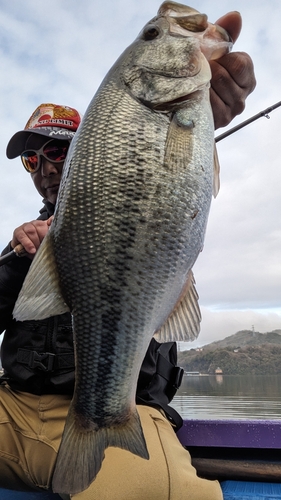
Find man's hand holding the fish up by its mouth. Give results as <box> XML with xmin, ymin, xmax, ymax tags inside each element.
<box><xmin>210</xmin><ymin>12</ymin><xmax>256</xmax><ymax>128</ymax></box>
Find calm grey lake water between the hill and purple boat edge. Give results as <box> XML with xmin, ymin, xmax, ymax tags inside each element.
<box><xmin>171</xmin><ymin>375</ymin><xmax>281</xmax><ymax>420</ymax></box>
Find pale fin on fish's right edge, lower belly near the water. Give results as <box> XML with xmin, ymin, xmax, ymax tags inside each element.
<box><xmin>154</xmin><ymin>271</ymin><xmax>201</xmax><ymax>342</ymax></box>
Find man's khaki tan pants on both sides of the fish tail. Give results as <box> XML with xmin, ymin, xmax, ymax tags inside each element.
<box><xmin>0</xmin><ymin>385</ymin><xmax>223</xmax><ymax>500</ymax></box>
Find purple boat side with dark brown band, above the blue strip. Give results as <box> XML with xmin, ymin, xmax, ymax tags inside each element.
<box><xmin>178</xmin><ymin>420</ymin><xmax>281</xmax><ymax>484</ymax></box>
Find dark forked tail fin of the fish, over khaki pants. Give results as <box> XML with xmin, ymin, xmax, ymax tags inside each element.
<box><xmin>52</xmin><ymin>410</ymin><xmax>149</xmax><ymax>495</ymax></box>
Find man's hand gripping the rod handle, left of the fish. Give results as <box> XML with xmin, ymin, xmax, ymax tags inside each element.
<box><xmin>11</xmin><ymin>217</ymin><xmax>52</xmax><ymax>259</ymax></box>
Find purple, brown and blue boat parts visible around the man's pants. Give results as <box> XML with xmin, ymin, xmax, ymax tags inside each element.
<box><xmin>0</xmin><ymin>420</ymin><xmax>281</xmax><ymax>500</ymax></box>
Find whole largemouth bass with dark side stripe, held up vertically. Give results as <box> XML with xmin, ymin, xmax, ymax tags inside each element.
<box><xmin>14</xmin><ymin>2</ymin><xmax>231</xmax><ymax>494</ymax></box>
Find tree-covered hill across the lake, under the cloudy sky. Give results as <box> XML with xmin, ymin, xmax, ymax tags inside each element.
<box><xmin>178</xmin><ymin>330</ymin><xmax>281</xmax><ymax>375</ymax></box>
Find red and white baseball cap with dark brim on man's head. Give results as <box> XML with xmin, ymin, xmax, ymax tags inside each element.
<box><xmin>6</xmin><ymin>103</ymin><xmax>82</xmax><ymax>159</ymax></box>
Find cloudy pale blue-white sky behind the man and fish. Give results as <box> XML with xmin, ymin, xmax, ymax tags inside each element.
<box><xmin>0</xmin><ymin>0</ymin><xmax>281</xmax><ymax>347</ymax></box>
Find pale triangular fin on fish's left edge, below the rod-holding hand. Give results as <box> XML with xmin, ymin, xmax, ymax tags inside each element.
<box><xmin>13</xmin><ymin>233</ymin><xmax>69</xmax><ymax>321</ymax></box>
